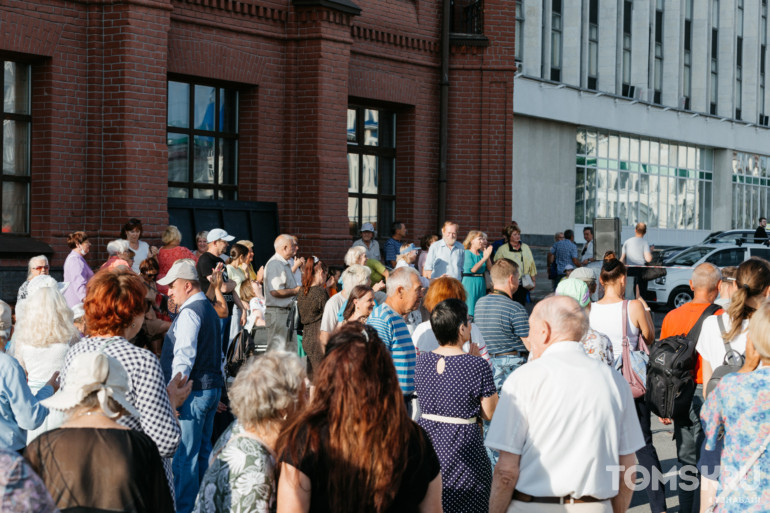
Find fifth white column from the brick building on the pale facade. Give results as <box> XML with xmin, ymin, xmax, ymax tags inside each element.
<box><xmin>653</xmin><ymin>2</ymin><xmax>684</xmax><ymax>108</ymax></box>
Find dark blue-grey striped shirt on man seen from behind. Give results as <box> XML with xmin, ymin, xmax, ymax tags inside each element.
<box><xmin>473</xmin><ymin>292</ymin><xmax>529</xmax><ymax>356</ymax></box>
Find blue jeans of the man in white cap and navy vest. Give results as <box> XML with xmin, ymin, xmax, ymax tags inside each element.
<box><xmin>171</xmin><ymin>388</ymin><xmax>222</xmax><ymax>513</ymax></box>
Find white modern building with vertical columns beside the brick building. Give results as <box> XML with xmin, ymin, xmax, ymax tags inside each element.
<box><xmin>513</xmin><ymin>0</ymin><xmax>770</xmax><ymax>245</ymax></box>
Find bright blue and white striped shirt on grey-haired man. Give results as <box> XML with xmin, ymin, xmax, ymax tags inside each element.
<box><xmin>366</xmin><ymin>303</ymin><xmax>417</xmax><ymax>395</ymax></box>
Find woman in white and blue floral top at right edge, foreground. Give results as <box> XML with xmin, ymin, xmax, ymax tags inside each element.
<box><xmin>701</xmin><ymin>300</ymin><xmax>770</xmax><ymax>513</ymax></box>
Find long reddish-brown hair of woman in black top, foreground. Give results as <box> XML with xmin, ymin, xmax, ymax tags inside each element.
<box><xmin>277</xmin><ymin>322</ymin><xmax>425</xmax><ymax>513</ymax></box>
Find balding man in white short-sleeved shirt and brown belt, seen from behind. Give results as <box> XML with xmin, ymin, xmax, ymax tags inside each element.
<box><xmin>485</xmin><ymin>296</ymin><xmax>644</xmax><ymax>513</ymax></box>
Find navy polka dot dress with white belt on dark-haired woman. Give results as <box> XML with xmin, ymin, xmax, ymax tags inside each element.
<box><xmin>414</xmin><ymin>352</ymin><xmax>496</xmax><ymax>513</ymax></box>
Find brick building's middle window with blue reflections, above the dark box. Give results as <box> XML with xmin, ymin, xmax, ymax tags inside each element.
<box><xmin>167</xmin><ymin>81</ymin><xmax>238</xmax><ymax>200</ymax></box>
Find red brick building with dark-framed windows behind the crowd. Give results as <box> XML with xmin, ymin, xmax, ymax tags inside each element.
<box><xmin>0</xmin><ymin>0</ymin><xmax>515</xmax><ymax>288</ymax></box>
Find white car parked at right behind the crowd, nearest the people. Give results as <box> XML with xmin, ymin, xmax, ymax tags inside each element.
<box><xmin>645</xmin><ymin>243</ymin><xmax>770</xmax><ymax>308</ymax></box>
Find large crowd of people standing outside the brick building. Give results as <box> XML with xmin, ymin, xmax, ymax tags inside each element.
<box><xmin>0</xmin><ymin>219</ymin><xmax>770</xmax><ymax>513</ymax></box>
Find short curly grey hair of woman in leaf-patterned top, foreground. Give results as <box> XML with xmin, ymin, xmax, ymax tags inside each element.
<box><xmin>228</xmin><ymin>351</ymin><xmax>305</xmax><ymax>428</ymax></box>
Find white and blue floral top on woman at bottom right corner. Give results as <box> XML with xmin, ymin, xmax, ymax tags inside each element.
<box><xmin>701</xmin><ymin>367</ymin><xmax>770</xmax><ymax>513</ymax></box>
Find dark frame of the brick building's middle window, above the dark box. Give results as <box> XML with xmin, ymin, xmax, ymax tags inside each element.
<box><xmin>166</xmin><ymin>75</ymin><xmax>242</xmax><ymax>200</ymax></box>
